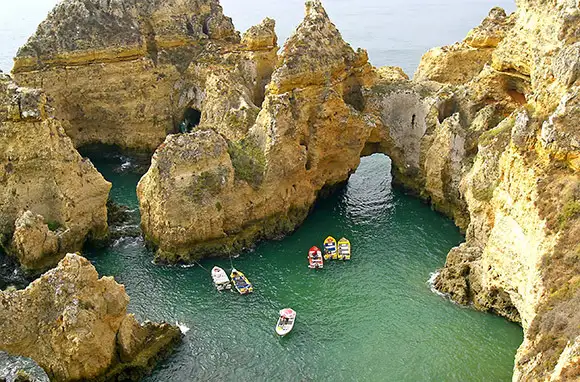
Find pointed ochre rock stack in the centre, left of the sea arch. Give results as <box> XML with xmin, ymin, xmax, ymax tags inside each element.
<box><xmin>138</xmin><ymin>1</ymin><xmax>373</xmax><ymax>261</ymax></box>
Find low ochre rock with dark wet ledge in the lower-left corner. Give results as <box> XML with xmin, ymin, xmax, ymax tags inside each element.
<box><xmin>0</xmin><ymin>254</ymin><xmax>181</xmax><ymax>381</ymax></box>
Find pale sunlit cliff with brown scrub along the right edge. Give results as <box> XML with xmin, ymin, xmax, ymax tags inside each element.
<box><xmin>418</xmin><ymin>0</ymin><xmax>580</xmax><ymax>380</ymax></box>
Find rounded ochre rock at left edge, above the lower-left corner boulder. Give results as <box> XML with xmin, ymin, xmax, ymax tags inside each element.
<box><xmin>0</xmin><ymin>74</ymin><xmax>111</xmax><ymax>272</ymax></box>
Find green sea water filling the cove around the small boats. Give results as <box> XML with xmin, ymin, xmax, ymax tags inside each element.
<box><xmin>86</xmin><ymin>155</ymin><xmax>522</xmax><ymax>382</ymax></box>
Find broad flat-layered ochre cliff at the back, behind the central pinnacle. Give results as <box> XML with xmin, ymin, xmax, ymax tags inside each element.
<box><xmin>13</xmin><ymin>0</ymin><xmax>277</xmax><ymax>152</ymax></box>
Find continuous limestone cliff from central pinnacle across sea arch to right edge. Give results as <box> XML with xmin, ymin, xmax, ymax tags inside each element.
<box><xmin>139</xmin><ymin>0</ymin><xmax>580</xmax><ymax>380</ymax></box>
